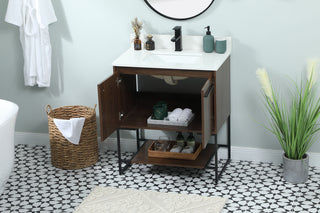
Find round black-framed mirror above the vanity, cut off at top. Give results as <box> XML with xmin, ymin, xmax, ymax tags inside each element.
<box><xmin>144</xmin><ymin>0</ymin><xmax>214</xmax><ymax>20</ymax></box>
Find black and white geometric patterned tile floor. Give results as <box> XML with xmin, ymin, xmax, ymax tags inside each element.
<box><xmin>0</xmin><ymin>145</ymin><xmax>320</xmax><ymax>213</ymax></box>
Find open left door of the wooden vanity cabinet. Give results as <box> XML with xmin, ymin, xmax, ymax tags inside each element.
<box><xmin>98</xmin><ymin>74</ymin><xmax>120</xmax><ymax>141</ymax></box>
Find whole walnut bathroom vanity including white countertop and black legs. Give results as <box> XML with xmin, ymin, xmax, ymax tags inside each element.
<box><xmin>98</xmin><ymin>36</ymin><xmax>231</xmax><ymax>183</ymax></box>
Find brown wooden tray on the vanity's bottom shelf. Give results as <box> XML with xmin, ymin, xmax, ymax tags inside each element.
<box><xmin>148</xmin><ymin>141</ymin><xmax>201</xmax><ymax>160</ymax></box>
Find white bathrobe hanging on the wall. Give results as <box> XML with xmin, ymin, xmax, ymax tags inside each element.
<box><xmin>5</xmin><ymin>0</ymin><xmax>57</xmax><ymax>87</ymax></box>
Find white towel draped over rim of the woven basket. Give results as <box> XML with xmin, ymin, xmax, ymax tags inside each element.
<box><xmin>53</xmin><ymin>118</ymin><xmax>85</xmax><ymax>145</ymax></box>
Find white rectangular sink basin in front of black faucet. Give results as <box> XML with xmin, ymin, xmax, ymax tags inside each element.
<box><xmin>145</xmin><ymin>52</ymin><xmax>202</xmax><ymax>64</ymax></box>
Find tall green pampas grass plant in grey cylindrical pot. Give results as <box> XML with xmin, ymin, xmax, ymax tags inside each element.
<box><xmin>256</xmin><ymin>61</ymin><xmax>320</xmax><ymax>184</ymax></box>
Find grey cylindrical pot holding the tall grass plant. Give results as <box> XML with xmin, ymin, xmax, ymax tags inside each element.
<box><xmin>283</xmin><ymin>154</ymin><xmax>309</xmax><ymax>184</ymax></box>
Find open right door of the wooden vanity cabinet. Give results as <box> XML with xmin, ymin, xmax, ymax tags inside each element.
<box><xmin>201</xmin><ymin>79</ymin><xmax>214</xmax><ymax>149</ymax></box>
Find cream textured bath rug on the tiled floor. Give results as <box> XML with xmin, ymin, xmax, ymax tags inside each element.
<box><xmin>74</xmin><ymin>187</ymin><xmax>227</xmax><ymax>213</ymax></box>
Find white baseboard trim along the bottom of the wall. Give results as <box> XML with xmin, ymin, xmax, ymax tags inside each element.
<box><xmin>15</xmin><ymin>132</ymin><xmax>320</xmax><ymax>167</ymax></box>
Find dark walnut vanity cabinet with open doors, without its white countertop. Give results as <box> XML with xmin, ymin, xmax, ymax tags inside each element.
<box><xmin>98</xmin><ymin>57</ymin><xmax>231</xmax><ymax>185</ymax></box>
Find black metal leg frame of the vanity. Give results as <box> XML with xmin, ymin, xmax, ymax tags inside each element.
<box><xmin>117</xmin><ymin>115</ymin><xmax>231</xmax><ymax>184</ymax></box>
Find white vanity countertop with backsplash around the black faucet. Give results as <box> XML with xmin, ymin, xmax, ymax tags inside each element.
<box><xmin>112</xmin><ymin>35</ymin><xmax>231</xmax><ymax>71</ymax></box>
